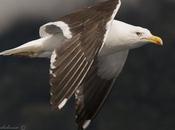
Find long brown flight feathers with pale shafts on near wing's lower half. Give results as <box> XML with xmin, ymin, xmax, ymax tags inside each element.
<box><xmin>50</xmin><ymin>35</ymin><xmax>93</xmax><ymax>109</ymax></box>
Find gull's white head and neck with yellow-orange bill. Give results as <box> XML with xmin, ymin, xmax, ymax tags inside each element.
<box><xmin>107</xmin><ymin>20</ymin><xmax>163</xmax><ymax>52</ymax></box>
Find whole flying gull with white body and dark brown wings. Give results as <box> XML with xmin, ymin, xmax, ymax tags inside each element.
<box><xmin>0</xmin><ymin>0</ymin><xmax>163</xmax><ymax>129</ymax></box>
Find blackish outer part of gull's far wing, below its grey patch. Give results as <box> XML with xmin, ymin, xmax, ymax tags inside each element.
<box><xmin>75</xmin><ymin>62</ymin><xmax>114</xmax><ymax>130</ymax></box>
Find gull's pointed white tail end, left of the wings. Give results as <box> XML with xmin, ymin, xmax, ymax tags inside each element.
<box><xmin>0</xmin><ymin>35</ymin><xmax>64</xmax><ymax>58</ymax></box>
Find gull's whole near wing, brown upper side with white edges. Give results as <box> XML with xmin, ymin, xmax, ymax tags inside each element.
<box><xmin>48</xmin><ymin>0</ymin><xmax>119</xmax><ymax>109</ymax></box>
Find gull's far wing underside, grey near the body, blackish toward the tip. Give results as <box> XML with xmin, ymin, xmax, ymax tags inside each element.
<box><xmin>75</xmin><ymin>51</ymin><xmax>128</xmax><ymax>129</ymax></box>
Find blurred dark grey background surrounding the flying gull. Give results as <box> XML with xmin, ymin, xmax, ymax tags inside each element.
<box><xmin>0</xmin><ymin>0</ymin><xmax>175</xmax><ymax>130</ymax></box>
